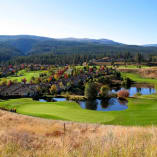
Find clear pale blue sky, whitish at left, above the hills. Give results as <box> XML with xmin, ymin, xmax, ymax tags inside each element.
<box><xmin>0</xmin><ymin>0</ymin><xmax>157</xmax><ymax>45</ymax></box>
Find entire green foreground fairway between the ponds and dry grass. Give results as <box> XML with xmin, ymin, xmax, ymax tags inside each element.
<box><xmin>0</xmin><ymin>95</ymin><xmax>157</xmax><ymax>126</ymax></box>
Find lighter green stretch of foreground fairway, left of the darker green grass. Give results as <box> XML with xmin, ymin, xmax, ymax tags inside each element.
<box><xmin>0</xmin><ymin>98</ymin><xmax>113</xmax><ymax>123</ymax></box>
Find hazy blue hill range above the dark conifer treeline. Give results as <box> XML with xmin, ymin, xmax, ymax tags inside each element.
<box><xmin>0</xmin><ymin>35</ymin><xmax>157</xmax><ymax>61</ymax></box>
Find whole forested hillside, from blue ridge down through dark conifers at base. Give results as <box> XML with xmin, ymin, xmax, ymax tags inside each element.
<box><xmin>0</xmin><ymin>35</ymin><xmax>157</xmax><ymax>64</ymax></box>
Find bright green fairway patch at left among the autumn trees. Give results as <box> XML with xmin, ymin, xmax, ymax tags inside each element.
<box><xmin>1</xmin><ymin>70</ymin><xmax>48</xmax><ymax>82</ymax></box>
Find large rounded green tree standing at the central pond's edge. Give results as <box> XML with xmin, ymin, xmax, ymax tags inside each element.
<box><xmin>85</xmin><ymin>83</ymin><xmax>98</xmax><ymax>100</ymax></box>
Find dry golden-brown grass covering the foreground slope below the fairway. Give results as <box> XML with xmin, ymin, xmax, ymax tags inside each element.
<box><xmin>0</xmin><ymin>111</ymin><xmax>157</xmax><ymax>157</ymax></box>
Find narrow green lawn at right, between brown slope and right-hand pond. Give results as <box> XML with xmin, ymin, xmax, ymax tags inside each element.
<box><xmin>121</xmin><ymin>73</ymin><xmax>157</xmax><ymax>84</ymax></box>
